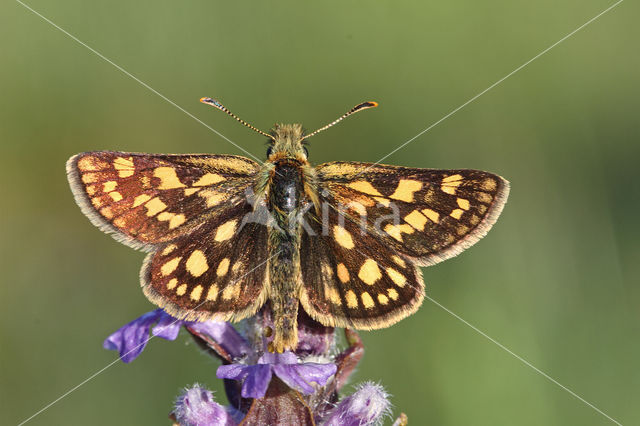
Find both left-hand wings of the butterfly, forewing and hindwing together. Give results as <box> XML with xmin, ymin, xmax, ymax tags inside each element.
<box><xmin>67</xmin><ymin>151</ymin><xmax>267</xmax><ymax>320</ymax></box>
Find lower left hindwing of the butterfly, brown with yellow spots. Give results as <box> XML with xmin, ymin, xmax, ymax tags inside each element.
<box><xmin>140</xmin><ymin>203</ymin><xmax>268</xmax><ymax>321</ymax></box>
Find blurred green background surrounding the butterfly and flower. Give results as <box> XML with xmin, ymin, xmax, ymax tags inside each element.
<box><xmin>0</xmin><ymin>0</ymin><xmax>640</xmax><ymax>425</ymax></box>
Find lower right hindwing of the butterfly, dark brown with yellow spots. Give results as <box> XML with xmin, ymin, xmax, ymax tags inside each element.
<box><xmin>300</xmin><ymin>209</ymin><xmax>424</xmax><ymax>330</ymax></box>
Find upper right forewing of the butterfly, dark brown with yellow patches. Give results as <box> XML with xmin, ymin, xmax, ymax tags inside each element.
<box><xmin>317</xmin><ymin>162</ymin><xmax>509</xmax><ymax>265</ymax></box>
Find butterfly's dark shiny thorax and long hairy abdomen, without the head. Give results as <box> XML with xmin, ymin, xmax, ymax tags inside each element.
<box><xmin>268</xmin><ymin>159</ymin><xmax>305</xmax><ymax>352</ymax></box>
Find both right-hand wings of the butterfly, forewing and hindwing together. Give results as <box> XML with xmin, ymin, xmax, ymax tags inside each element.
<box><xmin>300</xmin><ymin>162</ymin><xmax>509</xmax><ymax>329</ymax></box>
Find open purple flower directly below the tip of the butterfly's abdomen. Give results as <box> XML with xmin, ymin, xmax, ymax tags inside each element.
<box><xmin>217</xmin><ymin>352</ymin><xmax>337</xmax><ymax>398</ymax></box>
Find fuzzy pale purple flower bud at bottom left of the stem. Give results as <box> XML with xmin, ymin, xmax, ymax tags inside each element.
<box><xmin>173</xmin><ymin>384</ymin><xmax>237</xmax><ymax>426</ymax></box>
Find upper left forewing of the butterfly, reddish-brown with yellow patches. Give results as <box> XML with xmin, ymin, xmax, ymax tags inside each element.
<box><xmin>67</xmin><ymin>151</ymin><xmax>259</xmax><ymax>250</ymax></box>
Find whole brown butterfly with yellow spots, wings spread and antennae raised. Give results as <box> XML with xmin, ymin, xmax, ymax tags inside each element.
<box><xmin>67</xmin><ymin>98</ymin><xmax>509</xmax><ymax>352</ymax></box>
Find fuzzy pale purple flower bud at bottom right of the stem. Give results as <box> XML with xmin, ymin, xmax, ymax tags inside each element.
<box><xmin>323</xmin><ymin>382</ymin><xmax>390</xmax><ymax>426</ymax></box>
